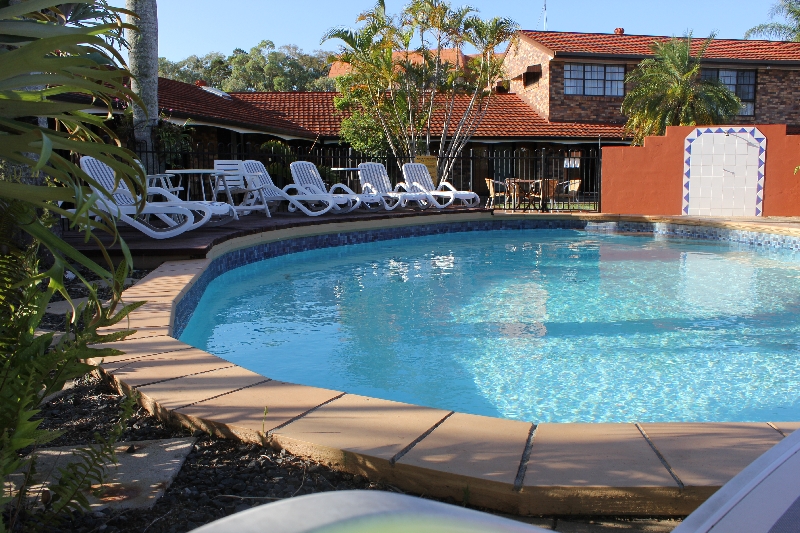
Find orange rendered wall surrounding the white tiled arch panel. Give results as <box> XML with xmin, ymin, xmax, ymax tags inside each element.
<box><xmin>601</xmin><ymin>124</ymin><xmax>800</xmax><ymax>216</ymax></box>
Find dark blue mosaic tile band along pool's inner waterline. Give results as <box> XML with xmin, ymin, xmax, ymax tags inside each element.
<box><xmin>172</xmin><ymin>219</ymin><xmax>800</xmax><ymax>339</ymax></box>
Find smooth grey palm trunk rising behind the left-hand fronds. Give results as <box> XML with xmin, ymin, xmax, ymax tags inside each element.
<box><xmin>125</xmin><ymin>0</ymin><xmax>158</xmax><ymax>174</ymax></box>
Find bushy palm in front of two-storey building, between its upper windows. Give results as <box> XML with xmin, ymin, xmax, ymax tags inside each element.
<box><xmin>622</xmin><ymin>33</ymin><xmax>742</xmax><ymax>145</ymax></box>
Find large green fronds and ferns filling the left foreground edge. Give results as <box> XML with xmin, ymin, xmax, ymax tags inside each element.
<box><xmin>0</xmin><ymin>0</ymin><xmax>146</xmax><ymax>531</ymax></box>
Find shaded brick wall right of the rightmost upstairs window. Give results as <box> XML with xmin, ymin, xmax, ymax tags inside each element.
<box><xmin>754</xmin><ymin>68</ymin><xmax>800</xmax><ymax>124</ymax></box>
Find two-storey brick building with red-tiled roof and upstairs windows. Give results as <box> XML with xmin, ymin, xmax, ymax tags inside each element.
<box><xmin>504</xmin><ymin>29</ymin><xmax>800</xmax><ymax>126</ymax></box>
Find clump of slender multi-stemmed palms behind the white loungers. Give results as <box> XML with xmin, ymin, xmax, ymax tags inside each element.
<box><xmin>323</xmin><ymin>0</ymin><xmax>517</xmax><ymax>179</ymax></box>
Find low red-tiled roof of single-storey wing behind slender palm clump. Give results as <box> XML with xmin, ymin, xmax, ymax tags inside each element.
<box><xmin>231</xmin><ymin>92</ymin><xmax>625</xmax><ymax>140</ymax></box>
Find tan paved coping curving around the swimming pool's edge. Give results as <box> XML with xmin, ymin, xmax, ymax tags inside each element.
<box><xmin>90</xmin><ymin>212</ymin><xmax>800</xmax><ymax>516</ymax></box>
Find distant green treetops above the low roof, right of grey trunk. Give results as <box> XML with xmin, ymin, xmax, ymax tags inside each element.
<box><xmin>158</xmin><ymin>40</ymin><xmax>333</xmax><ymax>92</ymax></box>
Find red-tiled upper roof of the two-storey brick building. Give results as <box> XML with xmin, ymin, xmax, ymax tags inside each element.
<box><xmin>519</xmin><ymin>30</ymin><xmax>800</xmax><ymax>63</ymax></box>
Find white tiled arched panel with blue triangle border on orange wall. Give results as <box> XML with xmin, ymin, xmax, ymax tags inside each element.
<box><xmin>681</xmin><ymin>126</ymin><xmax>767</xmax><ymax>217</ymax></box>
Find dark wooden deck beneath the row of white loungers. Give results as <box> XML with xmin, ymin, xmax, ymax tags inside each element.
<box><xmin>63</xmin><ymin>208</ymin><xmax>491</xmax><ymax>268</ymax></box>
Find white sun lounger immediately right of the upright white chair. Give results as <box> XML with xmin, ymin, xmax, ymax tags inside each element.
<box><xmin>239</xmin><ymin>159</ymin><xmax>334</xmax><ymax>217</ymax></box>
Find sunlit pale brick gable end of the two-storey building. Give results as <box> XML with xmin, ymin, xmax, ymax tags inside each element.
<box><xmin>503</xmin><ymin>37</ymin><xmax>550</xmax><ymax>120</ymax></box>
